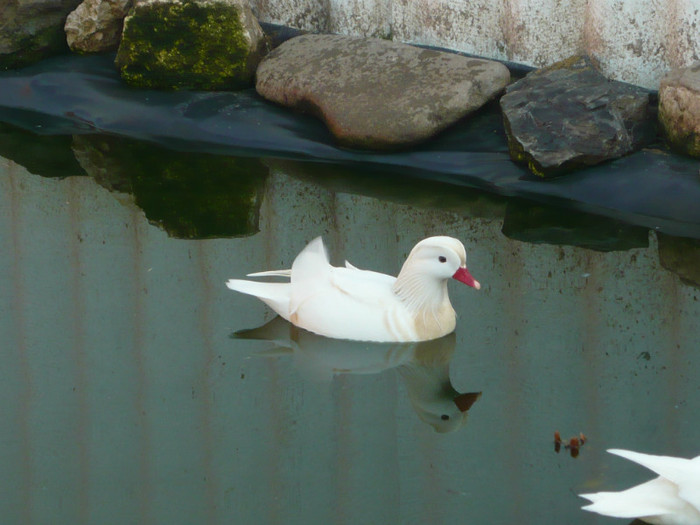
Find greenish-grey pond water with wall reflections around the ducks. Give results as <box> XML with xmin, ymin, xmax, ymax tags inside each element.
<box><xmin>0</xmin><ymin>127</ymin><xmax>700</xmax><ymax>524</ymax></box>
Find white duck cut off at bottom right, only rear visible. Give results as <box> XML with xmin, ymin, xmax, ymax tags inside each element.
<box><xmin>580</xmin><ymin>449</ymin><xmax>700</xmax><ymax>525</ymax></box>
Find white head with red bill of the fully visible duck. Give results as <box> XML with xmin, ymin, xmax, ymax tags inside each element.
<box><xmin>401</xmin><ymin>235</ymin><xmax>481</xmax><ymax>290</ymax></box>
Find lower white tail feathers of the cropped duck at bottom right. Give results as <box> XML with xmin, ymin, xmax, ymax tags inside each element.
<box><xmin>580</xmin><ymin>478</ymin><xmax>689</xmax><ymax>523</ymax></box>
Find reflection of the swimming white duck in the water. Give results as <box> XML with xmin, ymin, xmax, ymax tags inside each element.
<box><xmin>232</xmin><ymin>317</ymin><xmax>481</xmax><ymax>432</ymax></box>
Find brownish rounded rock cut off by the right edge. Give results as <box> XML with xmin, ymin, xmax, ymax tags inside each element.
<box><xmin>659</xmin><ymin>62</ymin><xmax>700</xmax><ymax>157</ymax></box>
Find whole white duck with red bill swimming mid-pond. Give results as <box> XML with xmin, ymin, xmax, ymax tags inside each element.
<box><xmin>226</xmin><ymin>236</ymin><xmax>481</xmax><ymax>342</ymax></box>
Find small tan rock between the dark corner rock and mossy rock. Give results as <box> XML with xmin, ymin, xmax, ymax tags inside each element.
<box><xmin>65</xmin><ymin>0</ymin><xmax>133</xmax><ymax>53</ymax></box>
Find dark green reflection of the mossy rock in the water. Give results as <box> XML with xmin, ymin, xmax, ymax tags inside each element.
<box><xmin>73</xmin><ymin>135</ymin><xmax>268</xmax><ymax>239</ymax></box>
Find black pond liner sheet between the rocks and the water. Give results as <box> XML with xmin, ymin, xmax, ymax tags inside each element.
<box><xmin>0</xmin><ymin>50</ymin><xmax>700</xmax><ymax>239</ymax></box>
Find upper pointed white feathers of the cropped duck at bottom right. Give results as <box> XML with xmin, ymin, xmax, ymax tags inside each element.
<box><xmin>608</xmin><ymin>449</ymin><xmax>700</xmax><ymax>515</ymax></box>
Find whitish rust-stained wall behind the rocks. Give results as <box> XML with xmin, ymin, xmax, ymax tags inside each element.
<box><xmin>250</xmin><ymin>0</ymin><xmax>700</xmax><ymax>89</ymax></box>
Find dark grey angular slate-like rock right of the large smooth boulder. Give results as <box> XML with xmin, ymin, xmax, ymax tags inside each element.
<box><xmin>501</xmin><ymin>57</ymin><xmax>656</xmax><ymax>177</ymax></box>
